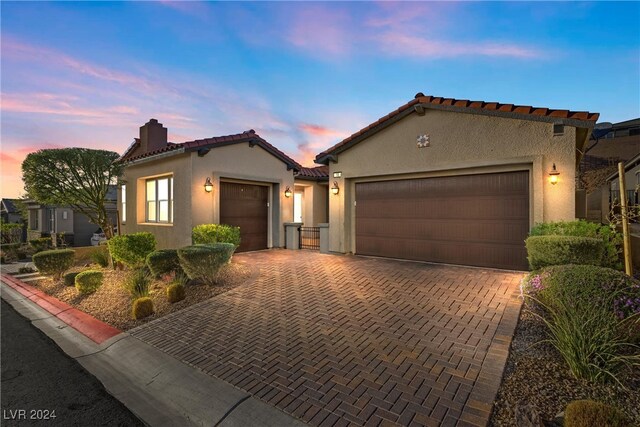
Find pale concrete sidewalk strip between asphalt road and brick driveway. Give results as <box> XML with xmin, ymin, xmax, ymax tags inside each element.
<box><xmin>1</xmin><ymin>276</ymin><xmax>304</xmax><ymax>427</ymax></box>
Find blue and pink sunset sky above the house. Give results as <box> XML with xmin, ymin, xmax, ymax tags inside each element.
<box><xmin>0</xmin><ymin>1</ymin><xmax>640</xmax><ymax>197</ymax></box>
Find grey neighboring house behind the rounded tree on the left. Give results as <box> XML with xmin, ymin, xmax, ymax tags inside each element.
<box><xmin>25</xmin><ymin>186</ymin><xmax>118</xmax><ymax>247</ymax></box>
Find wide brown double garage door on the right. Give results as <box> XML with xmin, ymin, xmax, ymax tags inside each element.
<box><xmin>355</xmin><ymin>171</ymin><xmax>529</xmax><ymax>270</ymax></box>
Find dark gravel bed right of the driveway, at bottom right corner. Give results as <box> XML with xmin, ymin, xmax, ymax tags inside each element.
<box><xmin>489</xmin><ymin>306</ymin><xmax>640</xmax><ymax>426</ymax></box>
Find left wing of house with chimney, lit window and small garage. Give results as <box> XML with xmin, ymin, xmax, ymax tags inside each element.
<box><xmin>118</xmin><ymin>119</ymin><xmax>302</xmax><ymax>251</ymax></box>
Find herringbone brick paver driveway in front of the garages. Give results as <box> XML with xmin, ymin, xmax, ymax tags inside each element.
<box><xmin>131</xmin><ymin>250</ymin><xmax>522</xmax><ymax>426</ymax></box>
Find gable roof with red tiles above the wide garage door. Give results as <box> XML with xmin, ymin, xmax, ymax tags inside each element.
<box><xmin>315</xmin><ymin>92</ymin><xmax>600</xmax><ymax>165</ymax></box>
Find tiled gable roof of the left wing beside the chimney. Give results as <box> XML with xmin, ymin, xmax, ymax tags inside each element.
<box><xmin>116</xmin><ymin>129</ymin><xmax>302</xmax><ymax>171</ymax></box>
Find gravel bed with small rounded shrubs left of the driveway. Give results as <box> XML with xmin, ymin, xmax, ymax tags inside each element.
<box><xmin>29</xmin><ymin>260</ymin><xmax>257</xmax><ymax>331</ymax></box>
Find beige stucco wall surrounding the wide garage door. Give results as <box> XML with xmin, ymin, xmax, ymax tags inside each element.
<box><xmin>329</xmin><ymin>110</ymin><xmax>576</xmax><ymax>253</ymax></box>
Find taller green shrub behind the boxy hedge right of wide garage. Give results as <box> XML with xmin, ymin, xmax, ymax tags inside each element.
<box><xmin>529</xmin><ymin>220</ymin><xmax>622</xmax><ymax>270</ymax></box>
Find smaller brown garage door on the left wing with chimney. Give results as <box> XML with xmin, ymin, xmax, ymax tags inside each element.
<box><xmin>220</xmin><ymin>182</ymin><xmax>269</xmax><ymax>252</ymax></box>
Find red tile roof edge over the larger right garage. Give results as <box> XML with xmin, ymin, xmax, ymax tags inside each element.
<box><xmin>315</xmin><ymin>92</ymin><xmax>600</xmax><ymax>163</ymax></box>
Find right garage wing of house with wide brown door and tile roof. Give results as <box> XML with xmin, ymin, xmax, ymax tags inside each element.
<box><xmin>316</xmin><ymin>93</ymin><xmax>598</xmax><ymax>269</ymax></box>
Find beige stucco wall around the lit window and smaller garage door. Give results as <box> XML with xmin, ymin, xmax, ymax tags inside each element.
<box><xmin>118</xmin><ymin>143</ymin><xmax>293</xmax><ymax>248</ymax></box>
